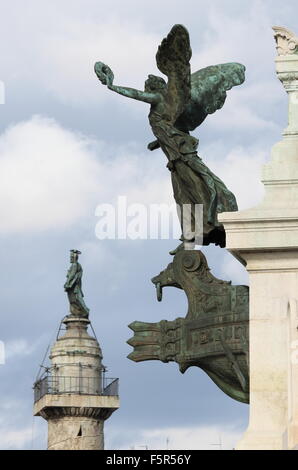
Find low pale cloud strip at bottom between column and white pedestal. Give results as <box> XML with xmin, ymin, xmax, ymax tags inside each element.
<box><xmin>107</xmin><ymin>425</ymin><xmax>243</xmax><ymax>450</ymax></box>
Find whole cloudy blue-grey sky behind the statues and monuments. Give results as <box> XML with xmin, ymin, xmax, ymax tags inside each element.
<box><xmin>0</xmin><ymin>0</ymin><xmax>298</xmax><ymax>449</ymax></box>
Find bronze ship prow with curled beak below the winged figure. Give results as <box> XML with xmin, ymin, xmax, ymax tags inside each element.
<box><xmin>128</xmin><ymin>250</ymin><xmax>249</xmax><ymax>403</ymax></box>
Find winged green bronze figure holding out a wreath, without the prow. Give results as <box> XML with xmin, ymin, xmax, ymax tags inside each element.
<box><xmin>95</xmin><ymin>24</ymin><xmax>245</xmax><ymax>248</ymax></box>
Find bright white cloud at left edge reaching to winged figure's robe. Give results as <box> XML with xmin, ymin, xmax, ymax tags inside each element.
<box><xmin>0</xmin><ymin>116</ymin><xmax>171</xmax><ymax>234</ymax></box>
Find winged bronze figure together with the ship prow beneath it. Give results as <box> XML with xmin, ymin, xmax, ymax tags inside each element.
<box><xmin>95</xmin><ymin>25</ymin><xmax>249</xmax><ymax>403</ymax></box>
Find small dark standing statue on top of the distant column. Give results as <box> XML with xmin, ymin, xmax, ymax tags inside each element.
<box><xmin>64</xmin><ymin>250</ymin><xmax>89</xmax><ymax>318</ymax></box>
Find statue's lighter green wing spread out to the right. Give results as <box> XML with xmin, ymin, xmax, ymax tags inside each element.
<box><xmin>175</xmin><ymin>62</ymin><xmax>245</xmax><ymax>132</ymax></box>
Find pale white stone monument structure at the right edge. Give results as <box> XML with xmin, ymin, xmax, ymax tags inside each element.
<box><xmin>219</xmin><ymin>27</ymin><xmax>298</xmax><ymax>450</ymax></box>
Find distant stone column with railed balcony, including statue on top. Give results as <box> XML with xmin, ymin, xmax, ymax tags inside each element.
<box><xmin>34</xmin><ymin>250</ymin><xmax>119</xmax><ymax>450</ymax></box>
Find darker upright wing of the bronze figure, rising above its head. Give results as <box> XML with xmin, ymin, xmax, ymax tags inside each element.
<box><xmin>156</xmin><ymin>24</ymin><xmax>191</xmax><ymax>121</ymax></box>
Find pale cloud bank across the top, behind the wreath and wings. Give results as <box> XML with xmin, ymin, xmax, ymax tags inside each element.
<box><xmin>0</xmin><ymin>0</ymin><xmax>286</xmax><ymax>125</ymax></box>
